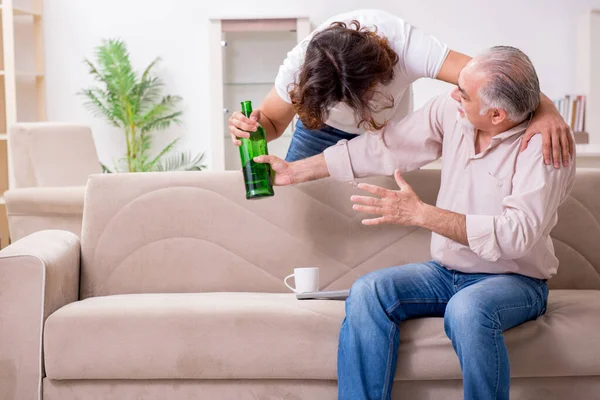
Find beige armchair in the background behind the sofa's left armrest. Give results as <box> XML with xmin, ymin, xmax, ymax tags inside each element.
<box><xmin>4</xmin><ymin>122</ymin><xmax>101</xmax><ymax>242</ymax></box>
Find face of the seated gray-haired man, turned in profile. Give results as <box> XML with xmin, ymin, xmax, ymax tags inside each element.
<box><xmin>451</xmin><ymin>62</ymin><xmax>493</xmax><ymax>130</ymax></box>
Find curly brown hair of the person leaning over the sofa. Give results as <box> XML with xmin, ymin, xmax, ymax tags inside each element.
<box><xmin>288</xmin><ymin>21</ymin><xmax>398</xmax><ymax>130</ymax></box>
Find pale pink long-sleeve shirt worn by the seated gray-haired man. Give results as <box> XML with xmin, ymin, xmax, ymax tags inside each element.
<box><xmin>324</xmin><ymin>95</ymin><xmax>575</xmax><ymax>279</ymax></box>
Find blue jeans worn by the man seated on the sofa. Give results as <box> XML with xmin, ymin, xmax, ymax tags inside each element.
<box><xmin>338</xmin><ymin>261</ymin><xmax>548</xmax><ymax>400</ymax></box>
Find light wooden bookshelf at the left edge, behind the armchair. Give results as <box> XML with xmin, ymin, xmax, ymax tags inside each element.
<box><xmin>0</xmin><ymin>0</ymin><xmax>46</xmax><ymax>248</ymax></box>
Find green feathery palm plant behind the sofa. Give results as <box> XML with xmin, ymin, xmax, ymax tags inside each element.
<box><xmin>79</xmin><ymin>39</ymin><xmax>205</xmax><ymax>172</ymax></box>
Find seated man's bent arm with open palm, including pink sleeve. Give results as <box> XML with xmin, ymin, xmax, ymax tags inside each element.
<box><xmin>351</xmin><ymin>140</ymin><xmax>575</xmax><ymax>262</ymax></box>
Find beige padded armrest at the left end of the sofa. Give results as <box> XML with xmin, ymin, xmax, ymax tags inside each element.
<box><xmin>0</xmin><ymin>230</ymin><xmax>80</xmax><ymax>400</ymax></box>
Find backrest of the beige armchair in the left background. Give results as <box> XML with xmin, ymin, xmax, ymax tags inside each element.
<box><xmin>8</xmin><ymin>122</ymin><xmax>102</xmax><ymax>188</ymax></box>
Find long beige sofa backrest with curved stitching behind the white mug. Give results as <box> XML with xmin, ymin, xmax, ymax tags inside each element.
<box><xmin>81</xmin><ymin>170</ymin><xmax>600</xmax><ymax>298</ymax></box>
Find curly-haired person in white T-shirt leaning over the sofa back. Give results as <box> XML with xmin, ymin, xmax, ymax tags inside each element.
<box><xmin>229</xmin><ymin>10</ymin><xmax>574</xmax><ymax>168</ymax></box>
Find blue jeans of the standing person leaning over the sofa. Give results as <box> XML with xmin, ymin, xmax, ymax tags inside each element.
<box><xmin>285</xmin><ymin>120</ymin><xmax>358</xmax><ymax>162</ymax></box>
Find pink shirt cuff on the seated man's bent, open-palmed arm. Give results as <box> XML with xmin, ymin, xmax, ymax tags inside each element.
<box><xmin>467</xmin><ymin>214</ymin><xmax>501</xmax><ymax>262</ymax></box>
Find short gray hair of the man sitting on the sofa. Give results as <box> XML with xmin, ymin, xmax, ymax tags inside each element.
<box><xmin>474</xmin><ymin>46</ymin><xmax>540</xmax><ymax>122</ymax></box>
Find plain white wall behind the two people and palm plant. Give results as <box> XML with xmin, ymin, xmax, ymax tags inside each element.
<box><xmin>45</xmin><ymin>0</ymin><xmax>600</xmax><ymax>168</ymax></box>
